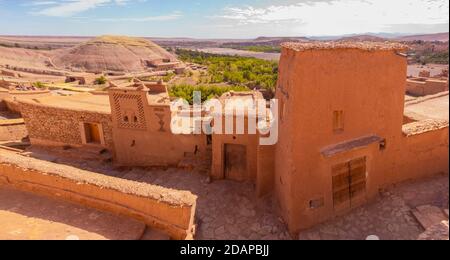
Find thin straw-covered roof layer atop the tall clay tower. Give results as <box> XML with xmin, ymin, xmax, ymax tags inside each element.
<box><xmin>281</xmin><ymin>41</ymin><xmax>408</xmax><ymax>51</ymax></box>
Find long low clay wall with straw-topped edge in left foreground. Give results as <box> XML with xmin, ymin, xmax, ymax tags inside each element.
<box><xmin>0</xmin><ymin>149</ymin><xmax>197</xmax><ymax>240</ymax></box>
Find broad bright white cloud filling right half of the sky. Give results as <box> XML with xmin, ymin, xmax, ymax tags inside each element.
<box><xmin>213</xmin><ymin>0</ymin><xmax>449</xmax><ymax>35</ymax></box>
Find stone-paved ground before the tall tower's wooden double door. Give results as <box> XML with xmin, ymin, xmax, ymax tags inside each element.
<box><xmin>299</xmin><ymin>175</ymin><xmax>449</xmax><ymax>240</ymax></box>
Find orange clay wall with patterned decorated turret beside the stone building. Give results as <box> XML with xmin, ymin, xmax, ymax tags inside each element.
<box><xmin>110</xmin><ymin>89</ymin><xmax>207</xmax><ymax>166</ymax></box>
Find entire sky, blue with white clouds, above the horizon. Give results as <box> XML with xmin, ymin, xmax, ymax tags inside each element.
<box><xmin>0</xmin><ymin>0</ymin><xmax>449</xmax><ymax>38</ymax></box>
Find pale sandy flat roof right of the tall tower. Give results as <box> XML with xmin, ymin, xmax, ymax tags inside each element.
<box><xmin>405</xmin><ymin>91</ymin><xmax>449</xmax><ymax>121</ymax></box>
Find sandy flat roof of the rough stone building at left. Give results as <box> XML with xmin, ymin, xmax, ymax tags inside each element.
<box><xmin>29</xmin><ymin>93</ymin><xmax>111</xmax><ymax>114</ymax></box>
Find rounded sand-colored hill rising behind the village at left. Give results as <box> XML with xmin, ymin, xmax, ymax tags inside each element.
<box><xmin>52</xmin><ymin>36</ymin><xmax>176</xmax><ymax>72</ymax></box>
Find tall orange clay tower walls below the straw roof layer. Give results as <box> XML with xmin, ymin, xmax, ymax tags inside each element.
<box><xmin>274</xmin><ymin>48</ymin><xmax>406</xmax><ymax>232</ymax></box>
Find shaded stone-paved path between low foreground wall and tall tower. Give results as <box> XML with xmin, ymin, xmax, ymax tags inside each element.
<box><xmin>122</xmin><ymin>169</ymin><xmax>291</xmax><ymax>240</ymax></box>
